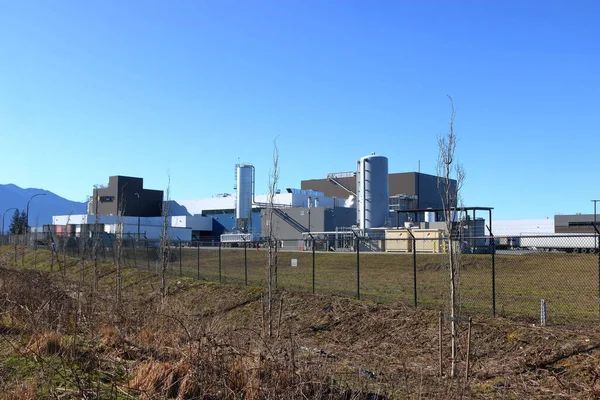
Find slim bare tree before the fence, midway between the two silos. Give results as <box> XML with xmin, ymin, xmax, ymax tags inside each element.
<box><xmin>266</xmin><ymin>139</ymin><xmax>279</xmax><ymax>337</ymax></box>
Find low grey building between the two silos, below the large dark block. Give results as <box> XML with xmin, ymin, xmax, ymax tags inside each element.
<box><xmin>261</xmin><ymin>207</ymin><xmax>356</xmax><ymax>240</ymax></box>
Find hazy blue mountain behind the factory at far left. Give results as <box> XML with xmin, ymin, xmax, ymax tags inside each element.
<box><xmin>0</xmin><ymin>184</ymin><xmax>87</xmax><ymax>233</ymax></box>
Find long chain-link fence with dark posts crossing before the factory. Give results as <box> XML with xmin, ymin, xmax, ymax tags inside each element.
<box><xmin>2</xmin><ymin>233</ymin><xmax>600</xmax><ymax>324</ymax></box>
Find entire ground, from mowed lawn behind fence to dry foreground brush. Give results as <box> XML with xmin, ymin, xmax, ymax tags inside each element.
<box><xmin>5</xmin><ymin>246</ymin><xmax>600</xmax><ymax>400</ymax></box>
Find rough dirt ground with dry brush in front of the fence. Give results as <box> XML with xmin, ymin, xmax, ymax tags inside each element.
<box><xmin>0</xmin><ymin>248</ymin><xmax>600</xmax><ymax>399</ymax></box>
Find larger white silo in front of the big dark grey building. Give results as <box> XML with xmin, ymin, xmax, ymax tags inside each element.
<box><xmin>356</xmin><ymin>153</ymin><xmax>390</xmax><ymax>229</ymax></box>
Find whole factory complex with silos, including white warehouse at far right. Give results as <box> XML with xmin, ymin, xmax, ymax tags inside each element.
<box><xmin>43</xmin><ymin>153</ymin><xmax>593</xmax><ymax>252</ymax></box>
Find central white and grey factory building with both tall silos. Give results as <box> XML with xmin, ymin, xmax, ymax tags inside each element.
<box><xmin>177</xmin><ymin>154</ymin><xmax>462</xmax><ymax>241</ymax></box>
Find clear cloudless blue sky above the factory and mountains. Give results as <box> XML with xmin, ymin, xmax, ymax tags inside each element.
<box><xmin>0</xmin><ymin>0</ymin><xmax>600</xmax><ymax>219</ymax></box>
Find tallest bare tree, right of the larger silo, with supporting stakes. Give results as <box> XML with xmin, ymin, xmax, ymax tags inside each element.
<box><xmin>437</xmin><ymin>96</ymin><xmax>466</xmax><ymax>377</ymax></box>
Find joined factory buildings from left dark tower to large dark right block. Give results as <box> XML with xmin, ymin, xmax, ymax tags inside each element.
<box><xmin>44</xmin><ymin>153</ymin><xmax>462</xmax><ymax>242</ymax></box>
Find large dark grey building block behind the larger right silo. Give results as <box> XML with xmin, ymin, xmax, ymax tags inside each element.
<box><xmin>301</xmin><ymin>172</ymin><xmax>456</xmax><ymax>209</ymax></box>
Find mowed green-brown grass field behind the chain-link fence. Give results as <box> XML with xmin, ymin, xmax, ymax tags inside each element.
<box><xmin>10</xmin><ymin>247</ymin><xmax>600</xmax><ymax>324</ymax></box>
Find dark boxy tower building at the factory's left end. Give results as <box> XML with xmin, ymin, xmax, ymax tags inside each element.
<box><xmin>88</xmin><ymin>175</ymin><xmax>163</xmax><ymax>217</ymax></box>
